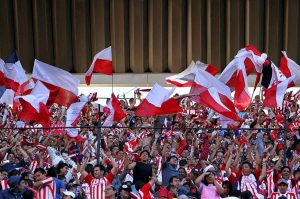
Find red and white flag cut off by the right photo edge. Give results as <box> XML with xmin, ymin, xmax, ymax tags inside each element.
<box><xmin>280</xmin><ymin>51</ymin><xmax>300</xmax><ymax>86</ymax></box>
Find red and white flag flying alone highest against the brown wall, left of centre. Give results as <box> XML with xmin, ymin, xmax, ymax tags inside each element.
<box><xmin>85</xmin><ymin>46</ymin><xmax>112</xmax><ymax>85</ymax></box>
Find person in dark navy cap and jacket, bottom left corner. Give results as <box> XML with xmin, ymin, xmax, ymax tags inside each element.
<box><xmin>0</xmin><ymin>176</ymin><xmax>25</xmax><ymax>199</ymax></box>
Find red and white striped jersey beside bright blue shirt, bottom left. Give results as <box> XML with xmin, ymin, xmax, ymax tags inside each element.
<box><xmin>37</xmin><ymin>177</ymin><xmax>56</xmax><ymax>199</ymax></box>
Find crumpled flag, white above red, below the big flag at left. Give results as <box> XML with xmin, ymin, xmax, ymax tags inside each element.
<box><xmin>15</xmin><ymin>82</ymin><xmax>50</xmax><ymax>126</ymax></box>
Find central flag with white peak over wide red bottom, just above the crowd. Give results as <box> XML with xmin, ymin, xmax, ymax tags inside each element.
<box><xmin>135</xmin><ymin>84</ymin><xmax>182</xmax><ymax>117</ymax></box>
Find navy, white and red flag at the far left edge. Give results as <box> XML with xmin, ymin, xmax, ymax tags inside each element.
<box><xmin>0</xmin><ymin>52</ymin><xmax>27</xmax><ymax>91</ymax></box>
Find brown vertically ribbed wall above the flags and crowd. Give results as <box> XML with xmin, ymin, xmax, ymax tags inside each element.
<box><xmin>0</xmin><ymin>0</ymin><xmax>300</xmax><ymax>74</ymax></box>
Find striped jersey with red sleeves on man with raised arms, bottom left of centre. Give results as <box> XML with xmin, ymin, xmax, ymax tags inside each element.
<box><xmin>85</xmin><ymin>172</ymin><xmax>115</xmax><ymax>199</ymax></box>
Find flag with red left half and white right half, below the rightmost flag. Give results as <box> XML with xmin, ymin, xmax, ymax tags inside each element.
<box><xmin>263</xmin><ymin>76</ymin><xmax>295</xmax><ymax>108</ymax></box>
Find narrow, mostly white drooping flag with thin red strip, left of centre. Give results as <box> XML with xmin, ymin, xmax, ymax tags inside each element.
<box><xmin>66</xmin><ymin>102</ymin><xmax>87</xmax><ymax>138</ymax></box>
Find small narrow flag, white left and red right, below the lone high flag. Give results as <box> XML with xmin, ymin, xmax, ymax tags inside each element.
<box><xmin>103</xmin><ymin>93</ymin><xmax>126</xmax><ymax>126</ymax></box>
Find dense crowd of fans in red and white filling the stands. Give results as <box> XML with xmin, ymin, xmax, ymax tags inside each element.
<box><xmin>0</xmin><ymin>91</ymin><xmax>300</xmax><ymax>199</ymax></box>
